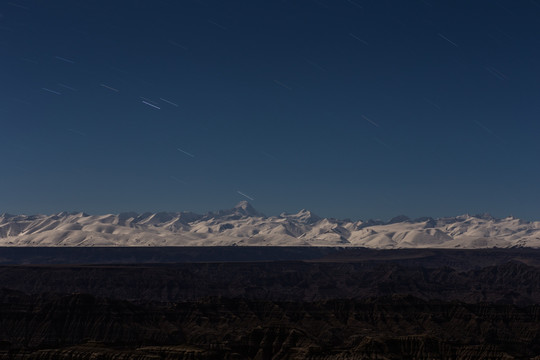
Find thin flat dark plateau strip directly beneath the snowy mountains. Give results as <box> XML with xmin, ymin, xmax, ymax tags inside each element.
<box><xmin>0</xmin><ymin>246</ymin><xmax>540</xmax><ymax>270</ymax></box>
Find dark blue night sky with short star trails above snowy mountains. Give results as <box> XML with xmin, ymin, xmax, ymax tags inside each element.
<box><xmin>0</xmin><ymin>0</ymin><xmax>540</xmax><ymax>219</ymax></box>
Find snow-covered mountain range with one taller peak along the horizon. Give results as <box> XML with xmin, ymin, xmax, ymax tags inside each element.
<box><xmin>0</xmin><ymin>201</ymin><xmax>540</xmax><ymax>249</ymax></box>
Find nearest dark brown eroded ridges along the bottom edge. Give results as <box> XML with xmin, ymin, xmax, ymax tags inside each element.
<box><xmin>0</xmin><ymin>290</ymin><xmax>540</xmax><ymax>360</ymax></box>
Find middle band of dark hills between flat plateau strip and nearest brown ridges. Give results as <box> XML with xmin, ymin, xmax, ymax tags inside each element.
<box><xmin>0</xmin><ymin>261</ymin><xmax>540</xmax><ymax>306</ymax></box>
